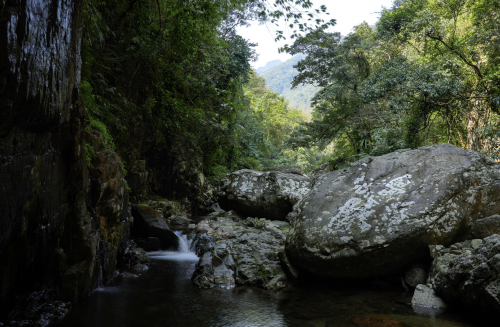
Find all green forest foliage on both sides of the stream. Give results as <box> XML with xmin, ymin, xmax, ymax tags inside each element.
<box><xmin>81</xmin><ymin>0</ymin><xmax>500</xmax><ymax>188</ymax></box>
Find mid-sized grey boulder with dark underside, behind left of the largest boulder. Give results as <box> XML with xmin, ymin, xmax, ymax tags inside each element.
<box><xmin>219</xmin><ymin>169</ymin><xmax>310</xmax><ymax>220</ymax></box>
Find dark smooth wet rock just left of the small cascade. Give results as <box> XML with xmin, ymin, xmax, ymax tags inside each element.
<box><xmin>132</xmin><ymin>204</ymin><xmax>179</xmax><ymax>249</ymax></box>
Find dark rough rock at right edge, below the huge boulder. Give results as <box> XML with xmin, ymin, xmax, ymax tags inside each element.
<box><xmin>430</xmin><ymin>235</ymin><xmax>500</xmax><ymax>317</ymax></box>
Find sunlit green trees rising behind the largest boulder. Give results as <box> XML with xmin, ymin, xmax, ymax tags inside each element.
<box><xmin>287</xmin><ymin>0</ymin><xmax>500</xmax><ymax>167</ymax></box>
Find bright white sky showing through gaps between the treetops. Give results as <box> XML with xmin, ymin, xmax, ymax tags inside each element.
<box><xmin>237</xmin><ymin>0</ymin><xmax>393</xmax><ymax>68</ymax></box>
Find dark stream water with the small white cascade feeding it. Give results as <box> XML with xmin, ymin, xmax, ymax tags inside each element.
<box><xmin>51</xmin><ymin>232</ymin><xmax>488</xmax><ymax>327</ymax></box>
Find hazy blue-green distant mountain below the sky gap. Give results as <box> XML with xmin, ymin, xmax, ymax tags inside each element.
<box><xmin>257</xmin><ymin>54</ymin><xmax>319</xmax><ymax>110</ymax></box>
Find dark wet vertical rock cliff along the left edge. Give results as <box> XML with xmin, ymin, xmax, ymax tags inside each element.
<box><xmin>0</xmin><ymin>0</ymin><xmax>128</xmax><ymax>314</ymax></box>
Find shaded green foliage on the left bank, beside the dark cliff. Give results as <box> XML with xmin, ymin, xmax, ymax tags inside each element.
<box><xmin>81</xmin><ymin>0</ymin><xmax>333</xmax><ymax>190</ymax></box>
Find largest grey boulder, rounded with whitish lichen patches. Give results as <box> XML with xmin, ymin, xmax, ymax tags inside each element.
<box><xmin>286</xmin><ymin>144</ymin><xmax>500</xmax><ymax>278</ymax></box>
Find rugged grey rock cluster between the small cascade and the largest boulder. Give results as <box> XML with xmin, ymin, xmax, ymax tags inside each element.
<box><xmin>192</xmin><ymin>211</ymin><xmax>296</xmax><ymax>289</ymax></box>
